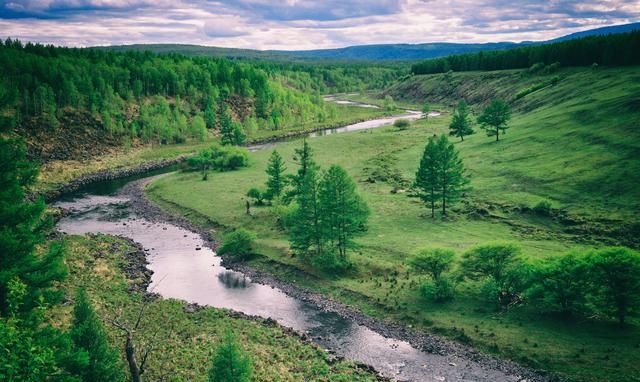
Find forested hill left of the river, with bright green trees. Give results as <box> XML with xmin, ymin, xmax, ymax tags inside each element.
<box><xmin>0</xmin><ymin>40</ymin><xmax>400</xmax><ymax>161</ymax></box>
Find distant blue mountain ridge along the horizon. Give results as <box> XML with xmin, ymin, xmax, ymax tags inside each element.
<box><xmin>99</xmin><ymin>22</ymin><xmax>640</xmax><ymax>62</ymax></box>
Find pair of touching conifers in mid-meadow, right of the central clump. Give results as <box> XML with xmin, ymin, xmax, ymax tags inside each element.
<box><xmin>414</xmin><ymin>135</ymin><xmax>469</xmax><ymax>218</ymax></box>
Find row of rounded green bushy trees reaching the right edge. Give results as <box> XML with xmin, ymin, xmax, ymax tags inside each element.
<box><xmin>408</xmin><ymin>242</ymin><xmax>640</xmax><ymax>325</ymax></box>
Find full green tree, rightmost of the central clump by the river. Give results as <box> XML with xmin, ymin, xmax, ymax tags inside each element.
<box><xmin>318</xmin><ymin>165</ymin><xmax>369</xmax><ymax>261</ymax></box>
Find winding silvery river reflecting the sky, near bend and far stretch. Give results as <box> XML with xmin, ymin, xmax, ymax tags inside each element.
<box><xmin>56</xmin><ymin>99</ymin><xmax>522</xmax><ymax>381</ymax></box>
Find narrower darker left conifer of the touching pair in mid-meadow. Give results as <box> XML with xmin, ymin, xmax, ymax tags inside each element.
<box><xmin>414</xmin><ymin>136</ymin><xmax>441</xmax><ymax>218</ymax></box>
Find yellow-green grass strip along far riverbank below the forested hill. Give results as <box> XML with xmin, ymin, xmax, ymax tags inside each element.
<box><xmin>34</xmin><ymin>105</ymin><xmax>383</xmax><ymax>192</ymax></box>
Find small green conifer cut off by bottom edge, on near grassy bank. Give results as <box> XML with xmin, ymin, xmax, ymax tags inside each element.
<box><xmin>209</xmin><ymin>331</ymin><xmax>252</xmax><ymax>382</ymax></box>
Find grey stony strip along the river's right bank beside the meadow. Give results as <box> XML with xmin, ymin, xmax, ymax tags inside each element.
<box><xmin>121</xmin><ymin>177</ymin><xmax>560</xmax><ymax>382</ymax></box>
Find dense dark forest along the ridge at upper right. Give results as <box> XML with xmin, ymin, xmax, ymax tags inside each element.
<box><xmin>411</xmin><ymin>31</ymin><xmax>640</xmax><ymax>74</ymax></box>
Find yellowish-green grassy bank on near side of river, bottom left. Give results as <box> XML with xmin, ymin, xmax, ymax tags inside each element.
<box><xmin>51</xmin><ymin>235</ymin><xmax>376</xmax><ymax>382</ymax></box>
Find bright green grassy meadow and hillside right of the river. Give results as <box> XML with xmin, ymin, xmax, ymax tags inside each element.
<box><xmin>149</xmin><ymin>68</ymin><xmax>640</xmax><ymax>381</ymax></box>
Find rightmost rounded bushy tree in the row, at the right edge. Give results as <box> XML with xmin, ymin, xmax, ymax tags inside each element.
<box><xmin>587</xmin><ymin>247</ymin><xmax>640</xmax><ymax>325</ymax></box>
